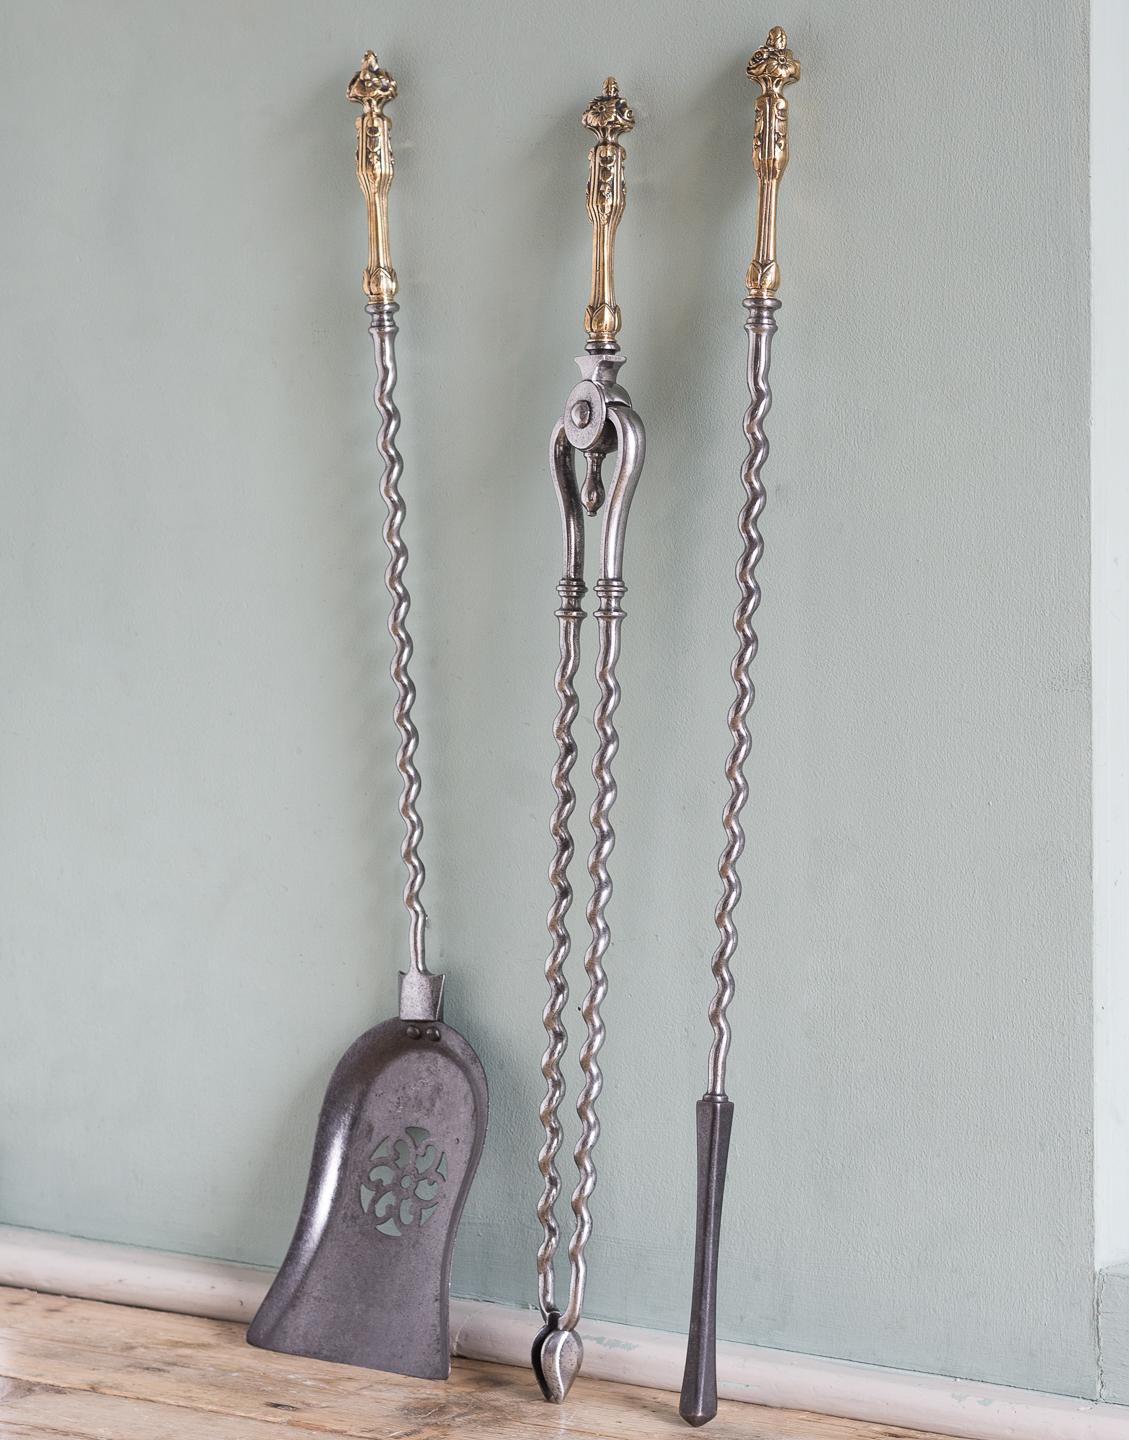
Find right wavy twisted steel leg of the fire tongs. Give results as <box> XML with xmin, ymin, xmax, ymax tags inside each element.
<box><xmin>560</xmin><ymin>576</ymin><xmax>626</xmax><ymax>1331</ymax></box>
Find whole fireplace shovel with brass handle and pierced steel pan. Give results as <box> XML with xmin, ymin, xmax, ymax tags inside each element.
<box><xmin>248</xmin><ymin>52</ymin><xmax>487</xmax><ymax>1380</ymax></box>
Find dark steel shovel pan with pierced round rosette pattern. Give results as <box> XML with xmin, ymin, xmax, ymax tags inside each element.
<box><xmin>248</xmin><ymin>1018</ymin><xmax>487</xmax><ymax>1380</ymax></box>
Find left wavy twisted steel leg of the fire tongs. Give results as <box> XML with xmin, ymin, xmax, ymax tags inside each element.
<box><xmin>537</xmin><ymin>576</ymin><xmax>585</xmax><ymax>1319</ymax></box>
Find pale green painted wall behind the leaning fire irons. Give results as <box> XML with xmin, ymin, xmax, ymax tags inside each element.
<box><xmin>0</xmin><ymin>0</ymin><xmax>1096</xmax><ymax>1394</ymax></box>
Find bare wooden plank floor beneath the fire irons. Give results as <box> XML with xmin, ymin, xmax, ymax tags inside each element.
<box><xmin>0</xmin><ymin>1289</ymin><xmax>961</xmax><ymax>1440</ymax></box>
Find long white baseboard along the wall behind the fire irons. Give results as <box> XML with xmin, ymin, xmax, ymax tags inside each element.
<box><xmin>0</xmin><ymin>1225</ymin><xmax>1129</xmax><ymax>1440</ymax></box>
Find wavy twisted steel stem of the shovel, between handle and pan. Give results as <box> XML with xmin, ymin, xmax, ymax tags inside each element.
<box><xmin>366</xmin><ymin>301</ymin><xmax>428</xmax><ymax>973</ymax></box>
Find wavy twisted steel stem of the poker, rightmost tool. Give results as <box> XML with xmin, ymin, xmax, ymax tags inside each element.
<box><xmin>707</xmin><ymin>297</ymin><xmax>781</xmax><ymax>1097</ymax></box>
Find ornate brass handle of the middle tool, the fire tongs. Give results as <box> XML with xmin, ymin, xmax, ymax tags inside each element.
<box><xmin>580</xmin><ymin>75</ymin><xmax>635</xmax><ymax>344</ymax></box>
